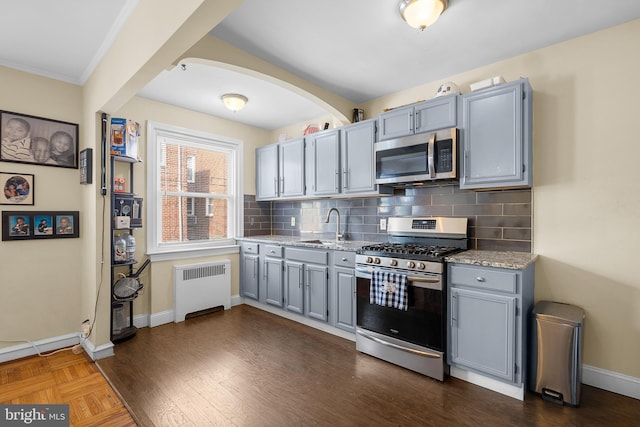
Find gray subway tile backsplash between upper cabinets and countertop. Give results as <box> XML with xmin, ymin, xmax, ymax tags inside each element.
<box><xmin>244</xmin><ymin>184</ymin><xmax>532</xmax><ymax>252</ymax></box>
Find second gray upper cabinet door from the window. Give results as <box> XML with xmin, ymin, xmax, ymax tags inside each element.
<box><xmin>279</xmin><ymin>138</ymin><xmax>304</xmax><ymax>197</ymax></box>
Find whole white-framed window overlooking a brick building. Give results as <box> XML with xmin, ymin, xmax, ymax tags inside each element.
<box><xmin>147</xmin><ymin>122</ymin><xmax>243</xmax><ymax>259</ymax></box>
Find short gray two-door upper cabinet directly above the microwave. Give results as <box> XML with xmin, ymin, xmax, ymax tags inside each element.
<box><xmin>379</xmin><ymin>94</ymin><xmax>459</xmax><ymax>141</ymax></box>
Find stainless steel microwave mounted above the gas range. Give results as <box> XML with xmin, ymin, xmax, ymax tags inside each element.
<box><xmin>375</xmin><ymin>128</ymin><xmax>458</xmax><ymax>185</ymax></box>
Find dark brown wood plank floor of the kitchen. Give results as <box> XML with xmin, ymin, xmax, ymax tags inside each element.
<box><xmin>97</xmin><ymin>305</ymin><xmax>640</xmax><ymax>426</ymax></box>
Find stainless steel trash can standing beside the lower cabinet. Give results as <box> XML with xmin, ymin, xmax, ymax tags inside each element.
<box><xmin>529</xmin><ymin>301</ymin><xmax>585</xmax><ymax>406</ymax></box>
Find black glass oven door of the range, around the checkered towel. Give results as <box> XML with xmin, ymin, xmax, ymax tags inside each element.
<box><xmin>356</xmin><ymin>266</ymin><xmax>446</xmax><ymax>352</ymax></box>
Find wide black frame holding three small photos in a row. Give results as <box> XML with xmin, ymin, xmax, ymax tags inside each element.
<box><xmin>2</xmin><ymin>211</ymin><xmax>80</xmax><ymax>241</ymax></box>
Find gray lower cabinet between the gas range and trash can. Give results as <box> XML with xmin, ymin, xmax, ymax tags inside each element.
<box><xmin>447</xmin><ymin>264</ymin><xmax>534</xmax><ymax>386</ymax></box>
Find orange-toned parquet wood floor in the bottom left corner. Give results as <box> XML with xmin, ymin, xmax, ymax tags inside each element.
<box><xmin>0</xmin><ymin>351</ymin><xmax>136</xmax><ymax>427</ymax></box>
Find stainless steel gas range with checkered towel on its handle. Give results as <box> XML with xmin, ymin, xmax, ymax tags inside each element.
<box><xmin>356</xmin><ymin>217</ymin><xmax>468</xmax><ymax>381</ymax></box>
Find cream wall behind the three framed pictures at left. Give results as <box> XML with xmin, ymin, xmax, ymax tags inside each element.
<box><xmin>0</xmin><ymin>67</ymin><xmax>84</xmax><ymax>347</ymax></box>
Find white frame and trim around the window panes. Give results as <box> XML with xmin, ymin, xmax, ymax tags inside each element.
<box><xmin>146</xmin><ymin>121</ymin><xmax>244</xmax><ymax>261</ymax></box>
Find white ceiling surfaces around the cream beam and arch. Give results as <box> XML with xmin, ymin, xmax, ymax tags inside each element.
<box><xmin>0</xmin><ymin>0</ymin><xmax>640</xmax><ymax>130</ymax></box>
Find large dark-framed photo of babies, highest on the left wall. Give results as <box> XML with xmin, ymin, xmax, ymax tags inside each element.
<box><xmin>0</xmin><ymin>111</ymin><xmax>78</xmax><ymax>169</ymax></box>
